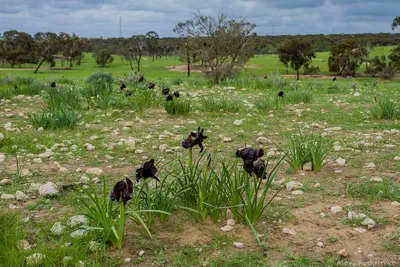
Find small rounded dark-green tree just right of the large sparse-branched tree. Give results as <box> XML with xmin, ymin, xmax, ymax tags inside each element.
<box><xmin>278</xmin><ymin>38</ymin><xmax>316</xmax><ymax>80</ymax></box>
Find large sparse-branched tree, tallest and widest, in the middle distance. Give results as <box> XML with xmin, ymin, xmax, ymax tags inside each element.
<box><xmin>174</xmin><ymin>13</ymin><xmax>256</xmax><ymax>83</ymax></box>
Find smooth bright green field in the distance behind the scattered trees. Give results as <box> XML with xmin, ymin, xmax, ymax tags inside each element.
<box><xmin>0</xmin><ymin>46</ymin><xmax>394</xmax><ymax>80</ymax></box>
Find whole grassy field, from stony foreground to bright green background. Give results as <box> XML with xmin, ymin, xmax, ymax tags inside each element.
<box><xmin>0</xmin><ymin>48</ymin><xmax>400</xmax><ymax>266</ymax></box>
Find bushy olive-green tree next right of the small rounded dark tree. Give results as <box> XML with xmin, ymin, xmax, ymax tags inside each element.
<box><xmin>328</xmin><ymin>38</ymin><xmax>368</xmax><ymax>75</ymax></box>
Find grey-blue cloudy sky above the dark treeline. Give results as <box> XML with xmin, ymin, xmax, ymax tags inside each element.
<box><xmin>0</xmin><ymin>0</ymin><xmax>400</xmax><ymax>37</ymax></box>
